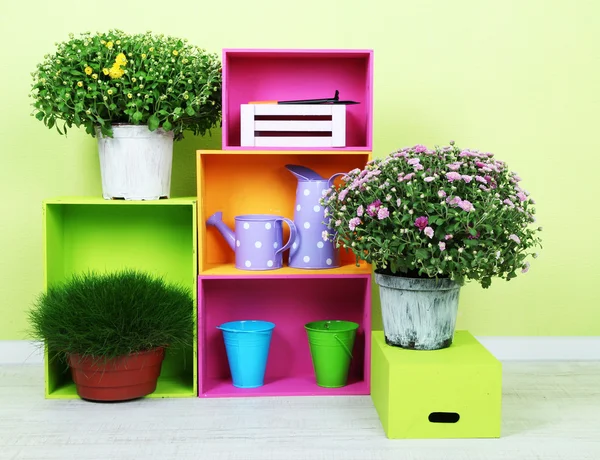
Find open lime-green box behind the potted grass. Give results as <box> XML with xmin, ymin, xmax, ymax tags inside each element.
<box><xmin>43</xmin><ymin>197</ymin><xmax>198</xmax><ymax>399</ymax></box>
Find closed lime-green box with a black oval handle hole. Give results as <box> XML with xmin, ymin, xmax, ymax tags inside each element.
<box><xmin>371</xmin><ymin>331</ymin><xmax>502</xmax><ymax>439</ymax></box>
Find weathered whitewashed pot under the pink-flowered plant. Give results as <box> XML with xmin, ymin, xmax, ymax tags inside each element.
<box><xmin>375</xmin><ymin>273</ymin><xmax>460</xmax><ymax>350</ymax></box>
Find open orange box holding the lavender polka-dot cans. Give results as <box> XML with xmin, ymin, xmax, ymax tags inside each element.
<box><xmin>196</xmin><ymin>150</ymin><xmax>371</xmax><ymax>276</ymax></box>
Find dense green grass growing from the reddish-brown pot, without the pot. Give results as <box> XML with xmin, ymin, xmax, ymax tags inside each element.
<box><xmin>29</xmin><ymin>270</ymin><xmax>194</xmax><ymax>359</ymax></box>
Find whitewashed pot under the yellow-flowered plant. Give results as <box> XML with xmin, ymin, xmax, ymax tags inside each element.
<box><xmin>97</xmin><ymin>125</ymin><xmax>173</xmax><ymax>200</ymax></box>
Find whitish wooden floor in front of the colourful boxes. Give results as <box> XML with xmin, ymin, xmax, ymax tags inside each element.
<box><xmin>0</xmin><ymin>362</ymin><xmax>600</xmax><ymax>460</ymax></box>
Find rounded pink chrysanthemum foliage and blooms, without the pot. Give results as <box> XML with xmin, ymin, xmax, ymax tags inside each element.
<box><xmin>321</xmin><ymin>142</ymin><xmax>542</xmax><ymax>288</ymax></box>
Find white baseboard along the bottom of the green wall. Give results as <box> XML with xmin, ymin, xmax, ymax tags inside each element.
<box><xmin>0</xmin><ymin>336</ymin><xmax>600</xmax><ymax>364</ymax></box>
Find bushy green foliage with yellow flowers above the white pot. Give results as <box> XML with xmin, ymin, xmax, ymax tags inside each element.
<box><xmin>31</xmin><ymin>30</ymin><xmax>222</xmax><ymax>140</ymax></box>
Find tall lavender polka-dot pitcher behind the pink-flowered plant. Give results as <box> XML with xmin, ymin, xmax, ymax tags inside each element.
<box><xmin>285</xmin><ymin>165</ymin><xmax>346</xmax><ymax>269</ymax></box>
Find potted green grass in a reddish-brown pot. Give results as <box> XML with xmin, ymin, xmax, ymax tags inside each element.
<box><xmin>28</xmin><ymin>269</ymin><xmax>194</xmax><ymax>401</ymax></box>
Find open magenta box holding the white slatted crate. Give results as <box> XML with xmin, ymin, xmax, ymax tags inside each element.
<box><xmin>222</xmin><ymin>49</ymin><xmax>373</xmax><ymax>151</ymax></box>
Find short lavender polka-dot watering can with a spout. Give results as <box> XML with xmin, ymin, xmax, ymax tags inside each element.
<box><xmin>206</xmin><ymin>211</ymin><xmax>296</xmax><ymax>270</ymax></box>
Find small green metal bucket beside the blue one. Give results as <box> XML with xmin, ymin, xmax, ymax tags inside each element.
<box><xmin>304</xmin><ymin>321</ymin><xmax>358</xmax><ymax>388</ymax></box>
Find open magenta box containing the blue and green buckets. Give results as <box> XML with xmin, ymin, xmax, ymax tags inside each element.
<box><xmin>198</xmin><ymin>274</ymin><xmax>371</xmax><ymax>397</ymax></box>
